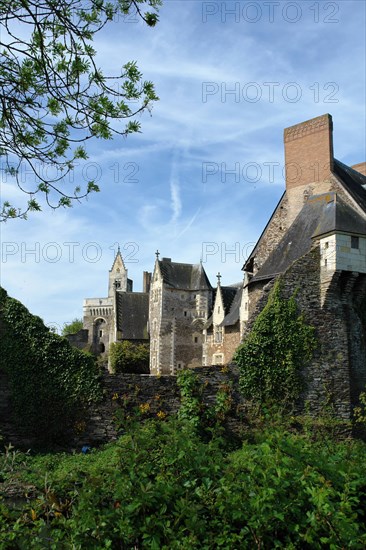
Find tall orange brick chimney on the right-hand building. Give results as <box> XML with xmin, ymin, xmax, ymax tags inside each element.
<box><xmin>284</xmin><ymin>114</ymin><xmax>333</xmax><ymax>193</ymax></box>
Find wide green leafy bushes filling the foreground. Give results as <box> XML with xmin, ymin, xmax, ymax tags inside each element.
<box><xmin>0</xmin><ymin>418</ymin><xmax>366</xmax><ymax>550</ymax></box>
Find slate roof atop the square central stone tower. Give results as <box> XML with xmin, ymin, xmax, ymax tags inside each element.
<box><xmin>158</xmin><ymin>258</ymin><xmax>212</xmax><ymax>290</ymax></box>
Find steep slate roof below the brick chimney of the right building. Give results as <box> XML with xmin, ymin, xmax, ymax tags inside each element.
<box><xmin>251</xmin><ymin>193</ymin><xmax>366</xmax><ymax>283</ymax></box>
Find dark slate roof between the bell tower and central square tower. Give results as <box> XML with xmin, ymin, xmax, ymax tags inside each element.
<box><xmin>117</xmin><ymin>292</ymin><xmax>149</xmax><ymax>340</ymax></box>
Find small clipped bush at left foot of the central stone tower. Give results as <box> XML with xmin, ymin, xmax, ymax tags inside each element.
<box><xmin>109</xmin><ymin>340</ymin><xmax>150</xmax><ymax>374</ymax></box>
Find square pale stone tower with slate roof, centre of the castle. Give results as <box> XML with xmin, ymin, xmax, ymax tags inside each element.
<box><xmin>149</xmin><ymin>254</ymin><xmax>212</xmax><ymax>374</ymax></box>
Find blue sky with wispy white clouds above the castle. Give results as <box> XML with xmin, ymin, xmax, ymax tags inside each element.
<box><xmin>0</xmin><ymin>0</ymin><xmax>366</xmax><ymax>328</ymax></box>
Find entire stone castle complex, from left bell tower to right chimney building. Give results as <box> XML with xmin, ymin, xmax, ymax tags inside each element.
<box><xmin>75</xmin><ymin>114</ymin><xmax>366</xmax><ymax>418</ymax></box>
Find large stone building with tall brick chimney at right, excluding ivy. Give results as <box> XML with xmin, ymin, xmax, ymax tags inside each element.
<box><xmin>241</xmin><ymin>114</ymin><xmax>366</xmax><ymax>419</ymax></box>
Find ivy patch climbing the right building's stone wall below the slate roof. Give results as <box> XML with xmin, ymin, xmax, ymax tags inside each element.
<box><xmin>234</xmin><ymin>281</ymin><xmax>316</xmax><ymax>404</ymax></box>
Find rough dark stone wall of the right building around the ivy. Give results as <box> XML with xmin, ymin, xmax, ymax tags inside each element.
<box><xmin>245</xmin><ymin>248</ymin><xmax>366</xmax><ymax>420</ymax></box>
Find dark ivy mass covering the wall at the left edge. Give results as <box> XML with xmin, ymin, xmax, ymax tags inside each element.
<box><xmin>0</xmin><ymin>287</ymin><xmax>101</xmax><ymax>441</ymax></box>
